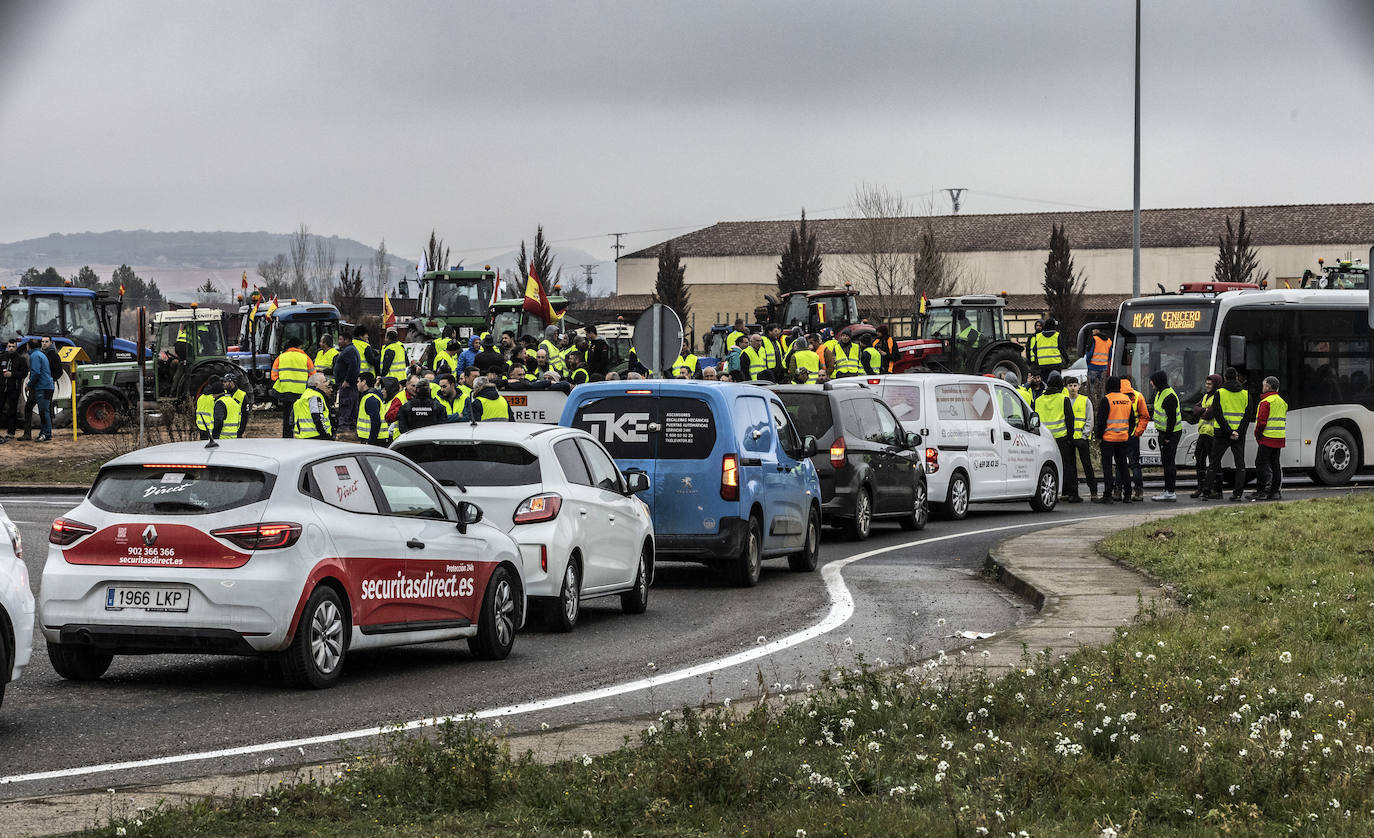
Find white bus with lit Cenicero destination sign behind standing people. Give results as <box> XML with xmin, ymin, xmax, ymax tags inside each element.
<box><xmin>1112</xmin><ymin>288</ymin><xmax>1374</xmax><ymax>486</ymax></box>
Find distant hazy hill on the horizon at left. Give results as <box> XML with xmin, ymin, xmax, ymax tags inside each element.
<box><xmin>0</xmin><ymin>229</ymin><xmax>415</xmax><ymax>293</ymax></box>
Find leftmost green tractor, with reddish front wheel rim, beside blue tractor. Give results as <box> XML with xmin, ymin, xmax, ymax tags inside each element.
<box><xmin>77</xmin><ymin>306</ymin><xmax>240</xmax><ymax>434</ymax></box>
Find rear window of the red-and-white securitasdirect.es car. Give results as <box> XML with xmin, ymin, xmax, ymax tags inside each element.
<box><xmin>91</xmin><ymin>464</ymin><xmax>276</xmax><ymax>515</ymax></box>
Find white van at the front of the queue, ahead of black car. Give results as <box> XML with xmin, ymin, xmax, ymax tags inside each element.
<box><xmin>845</xmin><ymin>372</ymin><xmax>1063</xmax><ymax>519</ymax></box>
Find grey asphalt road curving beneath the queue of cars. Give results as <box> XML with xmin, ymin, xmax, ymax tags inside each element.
<box><xmin>0</xmin><ymin>475</ymin><xmax>1368</xmax><ymax>800</ymax></box>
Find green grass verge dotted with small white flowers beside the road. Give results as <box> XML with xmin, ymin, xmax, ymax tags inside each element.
<box><xmin>80</xmin><ymin>497</ymin><xmax>1374</xmax><ymax>838</ymax></box>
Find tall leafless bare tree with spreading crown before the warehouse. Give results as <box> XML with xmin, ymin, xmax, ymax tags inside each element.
<box><xmin>846</xmin><ymin>183</ymin><xmax>914</xmax><ymax>320</ymax></box>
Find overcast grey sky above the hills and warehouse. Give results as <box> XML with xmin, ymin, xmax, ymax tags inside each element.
<box><xmin>0</xmin><ymin>0</ymin><xmax>1374</xmax><ymax>258</ymax></box>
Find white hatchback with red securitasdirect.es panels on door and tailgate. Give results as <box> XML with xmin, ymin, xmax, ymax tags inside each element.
<box><xmin>38</xmin><ymin>440</ymin><xmax>525</xmax><ymax>688</ymax></box>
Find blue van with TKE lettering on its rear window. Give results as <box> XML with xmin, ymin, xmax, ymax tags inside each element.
<box><xmin>559</xmin><ymin>381</ymin><xmax>820</xmax><ymax>587</ymax></box>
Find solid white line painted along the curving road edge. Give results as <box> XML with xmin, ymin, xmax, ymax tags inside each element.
<box><xmin>0</xmin><ymin>515</ymin><xmax>1112</xmax><ymax>786</ymax></box>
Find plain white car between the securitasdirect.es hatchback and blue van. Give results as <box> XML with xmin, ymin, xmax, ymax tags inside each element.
<box><xmin>392</xmin><ymin>422</ymin><xmax>654</xmax><ymax>632</ymax></box>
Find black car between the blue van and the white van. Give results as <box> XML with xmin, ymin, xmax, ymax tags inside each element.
<box><xmin>772</xmin><ymin>383</ymin><xmax>930</xmax><ymax>540</ymax></box>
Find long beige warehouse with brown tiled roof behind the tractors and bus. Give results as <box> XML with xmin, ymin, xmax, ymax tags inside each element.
<box><xmin>612</xmin><ymin>203</ymin><xmax>1374</xmax><ymax>334</ymax></box>
